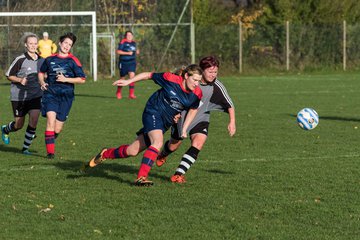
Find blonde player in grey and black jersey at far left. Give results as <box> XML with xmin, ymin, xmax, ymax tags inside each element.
<box><xmin>1</xmin><ymin>33</ymin><xmax>44</xmax><ymax>154</ymax></box>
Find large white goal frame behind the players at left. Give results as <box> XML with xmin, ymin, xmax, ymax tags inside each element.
<box><xmin>0</xmin><ymin>11</ymin><xmax>98</xmax><ymax>81</ymax></box>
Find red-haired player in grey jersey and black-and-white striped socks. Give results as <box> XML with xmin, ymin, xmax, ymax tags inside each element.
<box><xmin>156</xmin><ymin>56</ymin><xmax>236</xmax><ymax>183</ymax></box>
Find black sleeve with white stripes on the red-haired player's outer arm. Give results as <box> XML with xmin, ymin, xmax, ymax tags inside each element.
<box><xmin>208</xmin><ymin>80</ymin><xmax>234</xmax><ymax>112</ymax></box>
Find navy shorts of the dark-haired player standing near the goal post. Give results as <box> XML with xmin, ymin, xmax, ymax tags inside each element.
<box><xmin>41</xmin><ymin>94</ymin><xmax>74</xmax><ymax>122</ymax></box>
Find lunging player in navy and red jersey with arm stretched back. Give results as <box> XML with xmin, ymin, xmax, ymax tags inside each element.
<box><xmin>82</xmin><ymin>64</ymin><xmax>202</xmax><ymax>186</ymax></box>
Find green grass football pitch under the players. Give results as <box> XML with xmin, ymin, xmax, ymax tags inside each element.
<box><xmin>0</xmin><ymin>73</ymin><xmax>360</xmax><ymax>240</ymax></box>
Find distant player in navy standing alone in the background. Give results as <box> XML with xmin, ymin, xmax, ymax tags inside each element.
<box><xmin>116</xmin><ymin>31</ymin><xmax>140</xmax><ymax>99</ymax></box>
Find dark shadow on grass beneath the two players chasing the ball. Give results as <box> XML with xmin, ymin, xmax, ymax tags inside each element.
<box><xmin>54</xmin><ymin>160</ymin><xmax>168</xmax><ymax>185</ymax></box>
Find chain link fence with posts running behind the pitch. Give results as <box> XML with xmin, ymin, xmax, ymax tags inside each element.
<box><xmin>0</xmin><ymin>17</ymin><xmax>360</xmax><ymax>78</ymax></box>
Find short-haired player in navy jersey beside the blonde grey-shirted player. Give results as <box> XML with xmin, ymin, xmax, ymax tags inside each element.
<box><xmin>39</xmin><ymin>33</ymin><xmax>85</xmax><ymax>158</ymax></box>
